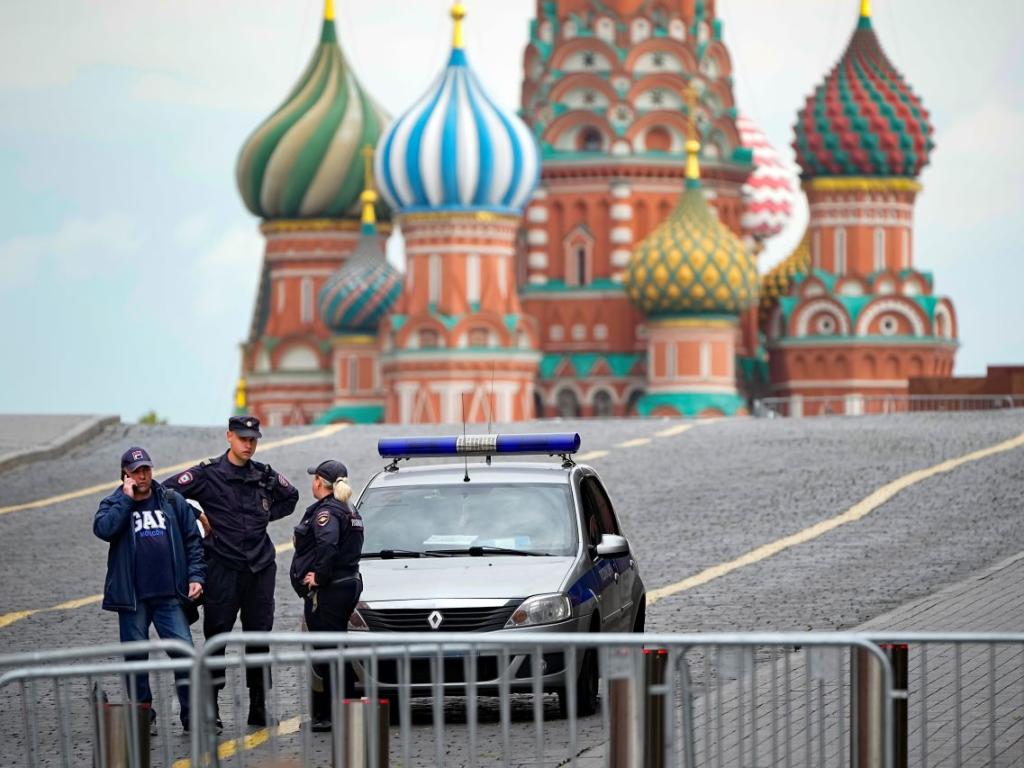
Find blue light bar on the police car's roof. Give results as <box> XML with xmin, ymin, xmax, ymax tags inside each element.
<box><xmin>377</xmin><ymin>432</ymin><xmax>580</xmax><ymax>459</ymax></box>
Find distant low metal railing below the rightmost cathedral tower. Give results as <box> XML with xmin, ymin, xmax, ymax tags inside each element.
<box><xmin>752</xmin><ymin>394</ymin><xmax>1024</xmax><ymax>418</ymax></box>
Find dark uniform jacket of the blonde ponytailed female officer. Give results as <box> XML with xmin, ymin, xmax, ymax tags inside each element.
<box><xmin>290</xmin><ymin>496</ymin><xmax>362</xmax><ymax>597</ymax></box>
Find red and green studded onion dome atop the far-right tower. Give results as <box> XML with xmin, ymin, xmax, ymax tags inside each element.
<box><xmin>793</xmin><ymin>0</ymin><xmax>934</xmax><ymax>178</ymax></box>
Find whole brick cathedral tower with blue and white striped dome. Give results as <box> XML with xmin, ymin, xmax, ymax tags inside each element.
<box><xmin>376</xmin><ymin>3</ymin><xmax>540</xmax><ymax>424</ymax></box>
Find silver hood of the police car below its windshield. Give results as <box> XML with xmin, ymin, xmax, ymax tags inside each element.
<box><xmin>359</xmin><ymin>555</ymin><xmax>575</xmax><ymax>607</ymax></box>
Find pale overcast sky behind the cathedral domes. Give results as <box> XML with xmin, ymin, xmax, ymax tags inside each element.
<box><xmin>0</xmin><ymin>0</ymin><xmax>1024</xmax><ymax>424</ymax></box>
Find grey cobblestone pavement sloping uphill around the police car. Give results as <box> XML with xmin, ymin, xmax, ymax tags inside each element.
<box><xmin>0</xmin><ymin>413</ymin><xmax>1024</xmax><ymax>765</ymax></box>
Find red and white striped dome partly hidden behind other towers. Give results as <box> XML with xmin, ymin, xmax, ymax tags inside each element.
<box><xmin>736</xmin><ymin>115</ymin><xmax>797</xmax><ymax>240</ymax></box>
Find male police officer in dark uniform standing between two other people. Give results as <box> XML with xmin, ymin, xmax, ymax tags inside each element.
<box><xmin>164</xmin><ymin>416</ymin><xmax>299</xmax><ymax>726</ymax></box>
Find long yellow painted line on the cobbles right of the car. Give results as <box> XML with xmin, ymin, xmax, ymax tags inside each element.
<box><xmin>647</xmin><ymin>434</ymin><xmax>1024</xmax><ymax>604</ymax></box>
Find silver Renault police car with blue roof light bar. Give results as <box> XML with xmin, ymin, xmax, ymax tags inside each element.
<box><xmin>349</xmin><ymin>433</ymin><xmax>646</xmax><ymax>715</ymax></box>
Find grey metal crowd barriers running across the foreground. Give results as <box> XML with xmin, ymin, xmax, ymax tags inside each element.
<box><xmin>0</xmin><ymin>633</ymin><xmax>1024</xmax><ymax>768</ymax></box>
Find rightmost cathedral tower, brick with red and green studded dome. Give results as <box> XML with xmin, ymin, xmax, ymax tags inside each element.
<box><xmin>763</xmin><ymin>0</ymin><xmax>957</xmax><ymax>415</ymax></box>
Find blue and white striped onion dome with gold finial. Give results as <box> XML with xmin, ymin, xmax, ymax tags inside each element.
<box><xmin>376</xmin><ymin>4</ymin><xmax>541</xmax><ymax>214</ymax></box>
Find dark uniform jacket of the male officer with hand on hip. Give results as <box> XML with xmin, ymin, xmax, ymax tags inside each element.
<box><xmin>164</xmin><ymin>451</ymin><xmax>299</xmax><ymax>572</ymax></box>
